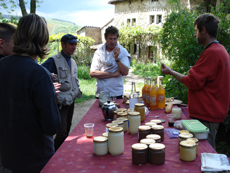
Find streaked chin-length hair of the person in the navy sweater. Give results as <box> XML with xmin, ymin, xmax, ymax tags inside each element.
<box><xmin>13</xmin><ymin>14</ymin><xmax>49</xmax><ymax>59</ymax></box>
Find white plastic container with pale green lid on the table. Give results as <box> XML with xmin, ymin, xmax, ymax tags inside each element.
<box><xmin>181</xmin><ymin>120</ymin><xmax>209</xmax><ymax>140</ymax></box>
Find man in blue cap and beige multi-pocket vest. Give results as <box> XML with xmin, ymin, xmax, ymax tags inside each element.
<box><xmin>42</xmin><ymin>34</ymin><xmax>82</xmax><ymax>150</ymax></box>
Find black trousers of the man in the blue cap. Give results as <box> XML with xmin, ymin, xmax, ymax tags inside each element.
<box><xmin>54</xmin><ymin>102</ymin><xmax>74</xmax><ymax>151</ymax></box>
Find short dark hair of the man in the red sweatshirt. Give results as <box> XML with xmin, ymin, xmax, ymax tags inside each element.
<box><xmin>194</xmin><ymin>14</ymin><xmax>220</xmax><ymax>38</ymax></box>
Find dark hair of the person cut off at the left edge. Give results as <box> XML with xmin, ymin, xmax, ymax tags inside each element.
<box><xmin>0</xmin><ymin>23</ymin><xmax>16</xmax><ymax>43</ymax></box>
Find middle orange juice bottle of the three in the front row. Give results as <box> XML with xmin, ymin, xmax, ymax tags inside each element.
<box><xmin>150</xmin><ymin>77</ymin><xmax>158</xmax><ymax>110</ymax></box>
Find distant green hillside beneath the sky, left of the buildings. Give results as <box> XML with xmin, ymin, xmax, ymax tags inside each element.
<box><xmin>47</xmin><ymin>19</ymin><xmax>81</xmax><ymax>35</ymax></box>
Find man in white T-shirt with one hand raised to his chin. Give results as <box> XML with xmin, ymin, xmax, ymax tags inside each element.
<box><xmin>90</xmin><ymin>26</ymin><xmax>131</xmax><ymax>99</ymax></box>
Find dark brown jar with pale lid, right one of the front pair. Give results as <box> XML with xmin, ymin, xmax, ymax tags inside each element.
<box><xmin>149</xmin><ymin>143</ymin><xmax>165</xmax><ymax>165</ymax></box>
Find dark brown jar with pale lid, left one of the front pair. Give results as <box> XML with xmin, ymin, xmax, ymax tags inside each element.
<box><xmin>132</xmin><ymin>143</ymin><xmax>149</xmax><ymax>165</ymax></box>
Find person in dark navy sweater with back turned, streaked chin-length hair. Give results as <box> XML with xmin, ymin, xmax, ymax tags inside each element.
<box><xmin>0</xmin><ymin>14</ymin><xmax>60</xmax><ymax>173</ymax></box>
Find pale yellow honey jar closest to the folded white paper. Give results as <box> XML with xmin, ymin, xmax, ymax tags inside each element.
<box><xmin>180</xmin><ymin>141</ymin><xmax>196</xmax><ymax>162</ymax></box>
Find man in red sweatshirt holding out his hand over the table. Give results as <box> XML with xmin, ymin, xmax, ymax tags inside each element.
<box><xmin>161</xmin><ymin>14</ymin><xmax>230</xmax><ymax>149</ymax></box>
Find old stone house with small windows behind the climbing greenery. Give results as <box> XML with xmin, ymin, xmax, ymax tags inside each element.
<box><xmin>77</xmin><ymin>0</ymin><xmax>221</xmax><ymax>62</ymax></box>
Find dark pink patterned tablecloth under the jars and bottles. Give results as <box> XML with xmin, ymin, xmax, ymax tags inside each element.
<box><xmin>41</xmin><ymin>100</ymin><xmax>215</xmax><ymax>173</ymax></box>
